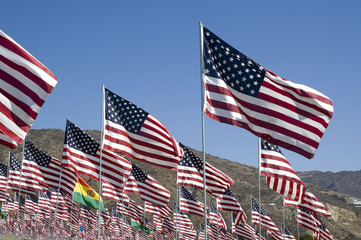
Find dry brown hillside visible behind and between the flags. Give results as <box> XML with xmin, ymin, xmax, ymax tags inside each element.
<box><xmin>0</xmin><ymin>129</ymin><xmax>361</xmax><ymax>239</ymax></box>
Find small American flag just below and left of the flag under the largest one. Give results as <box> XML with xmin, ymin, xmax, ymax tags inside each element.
<box><xmin>251</xmin><ymin>197</ymin><xmax>279</xmax><ymax>231</ymax></box>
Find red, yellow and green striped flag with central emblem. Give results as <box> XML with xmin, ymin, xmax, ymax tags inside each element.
<box><xmin>73</xmin><ymin>176</ymin><xmax>105</xmax><ymax>211</ymax></box>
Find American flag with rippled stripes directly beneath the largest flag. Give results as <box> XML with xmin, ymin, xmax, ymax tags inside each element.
<box><xmin>260</xmin><ymin>139</ymin><xmax>306</xmax><ymax>202</ymax></box>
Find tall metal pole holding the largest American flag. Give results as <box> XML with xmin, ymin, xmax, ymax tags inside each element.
<box><xmin>199</xmin><ymin>22</ymin><xmax>207</xmax><ymax>240</ymax></box>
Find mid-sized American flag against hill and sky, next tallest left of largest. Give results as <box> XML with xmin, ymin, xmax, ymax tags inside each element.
<box><xmin>104</xmin><ymin>89</ymin><xmax>182</xmax><ymax>170</ymax></box>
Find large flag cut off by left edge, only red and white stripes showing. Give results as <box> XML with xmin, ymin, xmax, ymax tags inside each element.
<box><xmin>0</xmin><ymin>30</ymin><xmax>57</xmax><ymax>148</ymax></box>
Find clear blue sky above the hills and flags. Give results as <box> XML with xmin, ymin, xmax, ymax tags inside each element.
<box><xmin>0</xmin><ymin>0</ymin><xmax>361</xmax><ymax>172</ymax></box>
